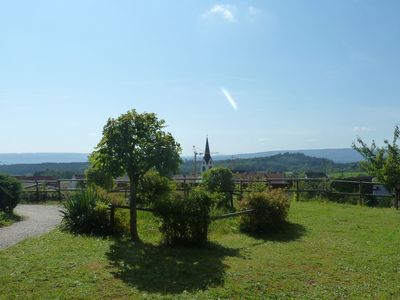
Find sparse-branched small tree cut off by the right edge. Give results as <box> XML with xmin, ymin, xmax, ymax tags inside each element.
<box><xmin>352</xmin><ymin>126</ymin><xmax>400</xmax><ymax>209</ymax></box>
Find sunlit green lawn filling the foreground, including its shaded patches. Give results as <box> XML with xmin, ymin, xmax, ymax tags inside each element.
<box><xmin>0</xmin><ymin>202</ymin><xmax>400</xmax><ymax>299</ymax></box>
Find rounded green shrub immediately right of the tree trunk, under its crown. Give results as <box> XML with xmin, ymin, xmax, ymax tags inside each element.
<box><xmin>138</xmin><ymin>170</ymin><xmax>174</xmax><ymax>207</ymax></box>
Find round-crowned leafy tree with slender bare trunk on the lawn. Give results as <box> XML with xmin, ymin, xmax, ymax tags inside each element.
<box><xmin>90</xmin><ymin>110</ymin><xmax>181</xmax><ymax>241</ymax></box>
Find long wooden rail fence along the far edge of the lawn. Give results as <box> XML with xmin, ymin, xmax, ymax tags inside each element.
<box><xmin>16</xmin><ymin>178</ymin><xmax>400</xmax><ymax>209</ymax></box>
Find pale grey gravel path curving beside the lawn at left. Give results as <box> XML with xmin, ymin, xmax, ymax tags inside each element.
<box><xmin>0</xmin><ymin>204</ymin><xmax>61</xmax><ymax>250</ymax></box>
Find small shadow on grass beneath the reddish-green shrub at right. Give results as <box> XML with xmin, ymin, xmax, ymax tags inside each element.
<box><xmin>245</xmin><ymin>222</ymin><xmax>306</xmax><ymax>242</ymax></box>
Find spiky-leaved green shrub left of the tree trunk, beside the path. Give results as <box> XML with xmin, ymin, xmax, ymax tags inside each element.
<box><xmin>61</xmin><ymin>187</ymin><xmax>114</xmax><ymax>235</ymax></box>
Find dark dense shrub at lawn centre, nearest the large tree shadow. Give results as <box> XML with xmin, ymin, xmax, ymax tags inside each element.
<box><xmin>155</xmin><ymin>189</ymin><xmax>211</xmax><ymax>245</ymax></box>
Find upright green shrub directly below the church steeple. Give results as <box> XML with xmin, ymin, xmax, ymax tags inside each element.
<box><xmin>202</xmin><ymin>168</ymin><xmax>235</xmax><ymax>209</ymax></box>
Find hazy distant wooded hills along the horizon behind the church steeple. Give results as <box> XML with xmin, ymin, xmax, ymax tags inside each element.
<box><xmin>0</xmin><ymin>153</ymin><xmax>360</xmax><ymax>179</ymax></box>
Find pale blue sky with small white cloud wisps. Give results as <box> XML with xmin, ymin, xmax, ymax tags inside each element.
<box><xmin>0</xmin><ymin>0</ymin><xmax>400</xmax><ymax>155</ymax></box>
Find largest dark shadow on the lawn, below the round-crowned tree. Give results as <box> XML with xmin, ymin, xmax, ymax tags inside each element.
<box><xmin>107</xmin><ymin>241</ymin><xmax>239</xmax><ymax>294</ymax></box>
